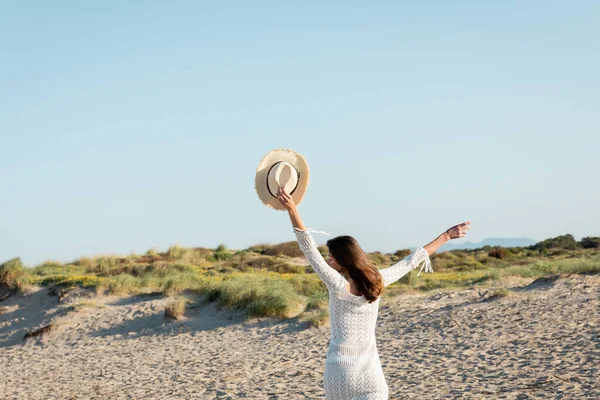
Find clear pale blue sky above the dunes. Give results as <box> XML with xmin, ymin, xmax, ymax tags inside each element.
<box><xmin>0</xmin><ymin>0</ymin><xmax>600</xmax><ymax>265</ymax></box>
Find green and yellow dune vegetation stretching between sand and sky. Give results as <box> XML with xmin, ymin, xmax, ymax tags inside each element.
<box><xmin>0</xmin><ymin>235</ymin><xmax>600</xmax><ymax>320</ymax></box>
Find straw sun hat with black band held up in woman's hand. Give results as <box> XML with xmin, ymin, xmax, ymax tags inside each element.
<box><xmin>254</xmin><ymin>149</ymin><xmax>309</xmax><ymax>210</ymax></box>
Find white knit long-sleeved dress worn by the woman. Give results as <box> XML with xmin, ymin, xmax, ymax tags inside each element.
<box><xmin>294</xmin><ymin>229</ymin><xmax>433</xmax><ymax>400</ymax></box>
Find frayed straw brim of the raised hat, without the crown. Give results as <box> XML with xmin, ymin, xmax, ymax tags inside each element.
<box><xmin>254</xmin><ymin>149</ymin><xmax>309</xmax><ymax>210</ymax></box>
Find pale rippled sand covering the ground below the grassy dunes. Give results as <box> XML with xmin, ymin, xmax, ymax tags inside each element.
<box><xmin>0</xmin><ymin>275</ymin><xmax>600</xmax><ymax>400</ymax></box>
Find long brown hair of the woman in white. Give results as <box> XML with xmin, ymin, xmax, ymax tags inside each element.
<box><xmin>327</xmin><ymin>236</ymin><xmax>383</xmax><ymax>303</ymax></box>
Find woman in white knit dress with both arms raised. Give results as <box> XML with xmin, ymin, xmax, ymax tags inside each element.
<box><xmin>277</xmin><ymin>188</ymin><xmax>470</xmax><ymax>400</ymax></box>
